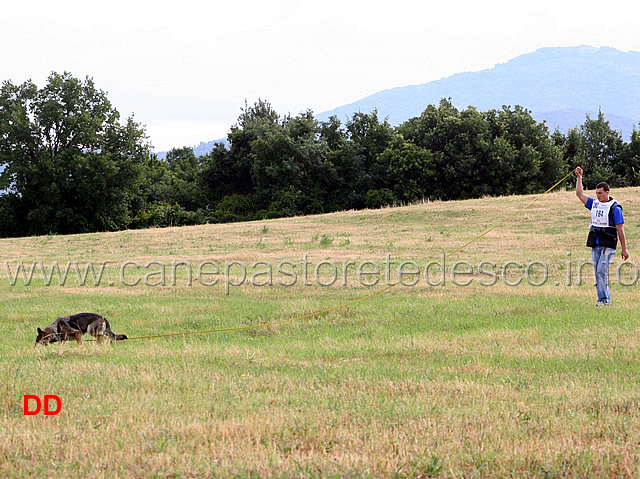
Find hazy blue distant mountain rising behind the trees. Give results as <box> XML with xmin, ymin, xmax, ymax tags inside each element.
<box><xmin>316</xmin><ymin>46</ymin><xmax>640</xmax><ymax>140</ymax></box>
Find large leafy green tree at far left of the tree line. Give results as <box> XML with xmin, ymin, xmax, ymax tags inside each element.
<box><xmin>0</xmin><ymin>73</ymin><xmax>150</xmax><ymax>236</ymax></box>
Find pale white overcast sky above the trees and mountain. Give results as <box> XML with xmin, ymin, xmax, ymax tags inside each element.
<box><xmin>0</xmin><ymin>0</ymin><xmax>640</xmax><ymax>151</ymax></box>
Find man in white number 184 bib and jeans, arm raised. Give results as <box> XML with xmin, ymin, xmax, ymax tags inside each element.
<box><xmin>576</xmin><ymin>167</ymin><xmax>629</xmax><ymax>306</ymax></box>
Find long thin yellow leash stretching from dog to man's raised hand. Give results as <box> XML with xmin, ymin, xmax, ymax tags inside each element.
<box><xmin>109</xmin><ymin>170</ymin><xmax>573</xmax><ymax>341</ymax></box>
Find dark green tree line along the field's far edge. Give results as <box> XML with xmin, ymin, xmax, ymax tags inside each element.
<box><xmin>0</xmin><ymin>73</ymin><xmax>640</xmax><ymax>237</ymax></box>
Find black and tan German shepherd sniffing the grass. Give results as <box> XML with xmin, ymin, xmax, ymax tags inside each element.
<box><xmin>36</xmin><ymin>313</ymin><xmax>127</xmax><ymax>345</ymax></box>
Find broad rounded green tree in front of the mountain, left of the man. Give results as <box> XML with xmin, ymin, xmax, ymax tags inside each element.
<box><xmin>398</xmin><ymin>99</ymin><xmax>564</xmax><ymax>199</ymax></box>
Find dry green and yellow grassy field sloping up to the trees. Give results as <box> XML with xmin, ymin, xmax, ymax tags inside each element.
<box><xmin>0</xmin><ymin>188</ymin><xmax>640</xmax><ymax>478</ymax></box>
